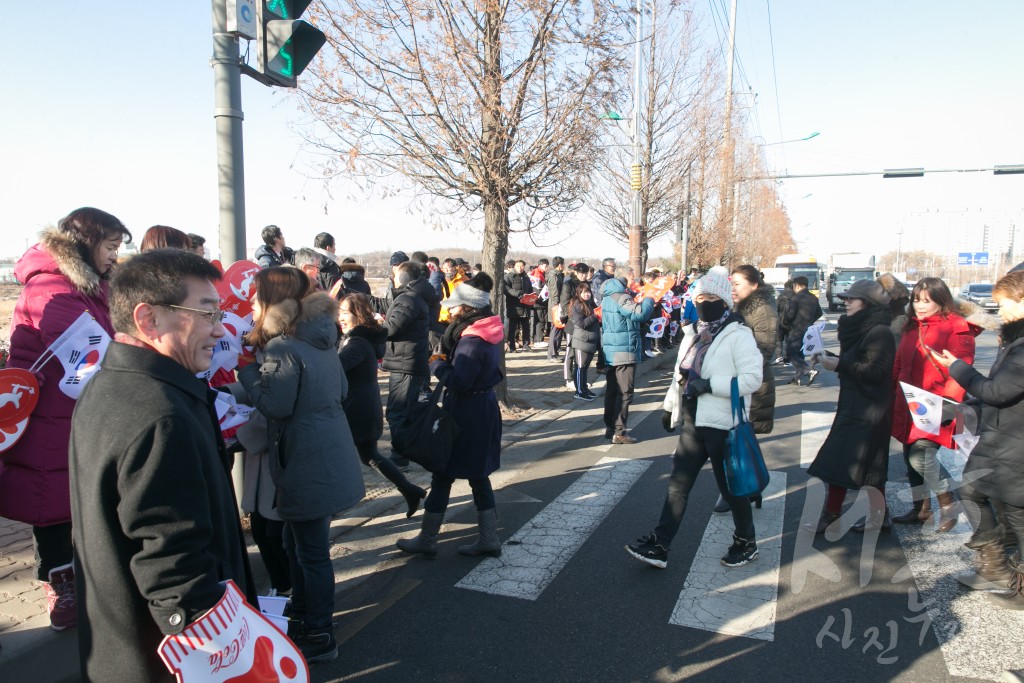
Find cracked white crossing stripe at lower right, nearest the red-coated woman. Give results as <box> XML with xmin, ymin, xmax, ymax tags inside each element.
<box><xmin>886</xmin><ymin>479</ymin><xmax>1024</xmax><ymax>681</ymax></box>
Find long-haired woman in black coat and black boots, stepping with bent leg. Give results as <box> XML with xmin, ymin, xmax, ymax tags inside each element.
<box><xmin>338</xmin><ymin>290</ymin><xmax>427</xmax><ymax>517</ymax></box>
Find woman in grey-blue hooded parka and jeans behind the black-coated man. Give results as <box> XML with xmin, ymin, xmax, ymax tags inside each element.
<box><xmin>239</xmin><ymin>266</ymin><xmax>366</xmax><ymax>661</ymax></box>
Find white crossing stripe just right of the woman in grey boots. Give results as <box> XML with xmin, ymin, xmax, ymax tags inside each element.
<box><xmin>456</xmin><ymin>457</ymin><xmax>650</xmax><ymax>600</ymax></box>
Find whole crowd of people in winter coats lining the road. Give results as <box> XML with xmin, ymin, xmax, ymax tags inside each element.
<box><xmin>0</xmin><ymin>208</ymin><xmax>1024</xmax><ymax>680</ymax></box>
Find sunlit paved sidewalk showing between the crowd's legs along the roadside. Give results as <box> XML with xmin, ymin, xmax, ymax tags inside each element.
<box><xmin>0</xmin><ymin>348</ymin><xmax>676</xmax><ymax>683</ymax></box>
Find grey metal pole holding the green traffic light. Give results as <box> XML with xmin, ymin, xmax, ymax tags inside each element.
<box><xmin>210</xmin><ymin>0</ymin><xmax>246</xmax><ymax>265</ymax></box>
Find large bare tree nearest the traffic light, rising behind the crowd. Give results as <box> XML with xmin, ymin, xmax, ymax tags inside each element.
<box><xmin>301</xmin><ymin>0</ymin><xmax>623</xmax><ymax>402</ymax></box>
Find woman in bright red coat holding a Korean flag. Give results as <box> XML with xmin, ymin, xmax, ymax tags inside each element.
<box><xmin>893</xmin><ymin>278</ymin><xmax>981</xmax><ymax>533</ymax></box>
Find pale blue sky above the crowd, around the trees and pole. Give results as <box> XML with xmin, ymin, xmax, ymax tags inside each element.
<box><xmin>0</xmin><ymin>0</ymin><xmax>1024</xmax><ymax>264</ymax></box>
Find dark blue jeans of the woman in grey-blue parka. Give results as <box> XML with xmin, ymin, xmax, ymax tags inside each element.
<box><xmin>285</xmin><ymin>517</ymin><xmax>334</xmax><ymax>629</ymax></box>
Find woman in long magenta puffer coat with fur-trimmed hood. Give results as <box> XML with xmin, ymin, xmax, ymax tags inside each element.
<box><xmin>0</xmin><ymin>207</ymin><xmax>131</xmax><ymax>631</ymax></box>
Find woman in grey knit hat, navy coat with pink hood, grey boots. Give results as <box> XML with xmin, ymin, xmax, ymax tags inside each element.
<box><xmin>397</xmin><ymin>272</ymin><xmax>504</xmax><ymax>557</ymax></box>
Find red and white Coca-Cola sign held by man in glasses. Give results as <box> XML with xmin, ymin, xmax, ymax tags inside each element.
<box><xmin>158</xmin><ymin>581</ymin><xmax>309</xmax><ymax>683</ymax></box>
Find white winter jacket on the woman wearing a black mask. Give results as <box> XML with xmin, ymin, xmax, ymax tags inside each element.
<box><xmin>663</xmin><ymin>323</ymin><xmax>763</xmax><ymax>429</ymax></box>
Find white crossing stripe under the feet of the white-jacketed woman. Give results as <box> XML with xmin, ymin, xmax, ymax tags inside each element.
<box><xmin>669</xmin><ymin>471</ymin><xmax>786</xmax><ymax>641</ymax></box>
